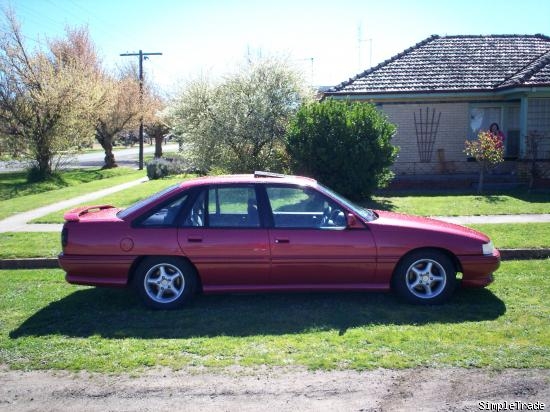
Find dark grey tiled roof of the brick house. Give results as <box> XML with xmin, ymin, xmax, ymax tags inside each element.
<box><xmin>327</xmin><ymin>34</ymin><xmax>550</xmax><ymax>95</ymax></box>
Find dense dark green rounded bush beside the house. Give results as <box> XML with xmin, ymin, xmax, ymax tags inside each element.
<box><xmin>286</xmin><ymin>99</ymin><xmax>398</xmax><ymax>200</ymax></box>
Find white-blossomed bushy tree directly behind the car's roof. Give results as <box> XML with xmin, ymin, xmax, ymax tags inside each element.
<box><xmin>171</xmin><ymin>59</ymin><xmax>307</xmax><ymax>172</ymax></box>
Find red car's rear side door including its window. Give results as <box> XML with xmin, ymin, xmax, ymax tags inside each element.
<box><xmin>178</xmin><ymin>185</ymin><xmax>270</xmax><ymax>292</ymax></box>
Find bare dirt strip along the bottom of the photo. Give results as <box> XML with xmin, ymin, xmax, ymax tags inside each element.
<box><xmin>0</xmin><ymin>368</ymin><xmax>550</xmax><ymax>412</ymax></box>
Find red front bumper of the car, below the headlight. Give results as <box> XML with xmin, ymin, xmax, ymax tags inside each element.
<box><xmin>458</xmin><ymin>249</ymin><xmax>500</xmax><ymax>288</ymax></box>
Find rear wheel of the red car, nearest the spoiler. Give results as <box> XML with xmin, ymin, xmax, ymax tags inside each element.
<box><xmin>134</xmin><ymin>257</ymin><xmax>197</xmax><ymax>309</ymax></box>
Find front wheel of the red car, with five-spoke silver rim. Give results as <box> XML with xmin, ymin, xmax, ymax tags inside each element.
<box><xmin>392</xmin><ymin>250</ymin><xmax>456</xmax><ymax>305</ymax></box>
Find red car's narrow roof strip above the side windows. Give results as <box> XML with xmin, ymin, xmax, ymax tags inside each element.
<box><xmin>180</xmin><ymin>172</ymin><xmax>317</xmax><ymax>187</ymax></box>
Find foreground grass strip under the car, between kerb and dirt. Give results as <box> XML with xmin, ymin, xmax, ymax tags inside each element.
<box><xmin>0</xmin><ymin>260</ymin><xmax>550</xmax><ymax>373</ymax></box>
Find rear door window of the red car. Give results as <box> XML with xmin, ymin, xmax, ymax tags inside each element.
<box><xmin>185</xmin><ymin>185</ymin><xmax>260</xmax><ymax>228</ymax></box>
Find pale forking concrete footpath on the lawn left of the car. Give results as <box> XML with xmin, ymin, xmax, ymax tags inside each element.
<box><xmin>0</xmin><ymin>177</ymin><xmax>149</xmax><ymax>233</ymax></box>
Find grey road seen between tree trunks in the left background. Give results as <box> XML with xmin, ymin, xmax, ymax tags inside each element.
<box><xmin>0</xmin><ymin>143</ymin><xmax>178</xmax><ymax>172</ymax></box>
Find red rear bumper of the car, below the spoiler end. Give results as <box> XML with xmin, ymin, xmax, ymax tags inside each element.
<box><xmin>57</xmin><ymin>253</ymin><xmax>135</xmax><ymax>287</ymax></box>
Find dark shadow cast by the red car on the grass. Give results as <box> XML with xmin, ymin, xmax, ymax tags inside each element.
<box><xmin>10</xmin><ymin>288</ymin><xmax>506</xmax><ymax>339</ymax></box>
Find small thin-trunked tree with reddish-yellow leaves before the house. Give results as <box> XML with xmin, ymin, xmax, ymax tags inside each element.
<box><xmin>464</xmin><ymin>131</ymin><xmax>504</xmax><ymax>193</ymax></box>
